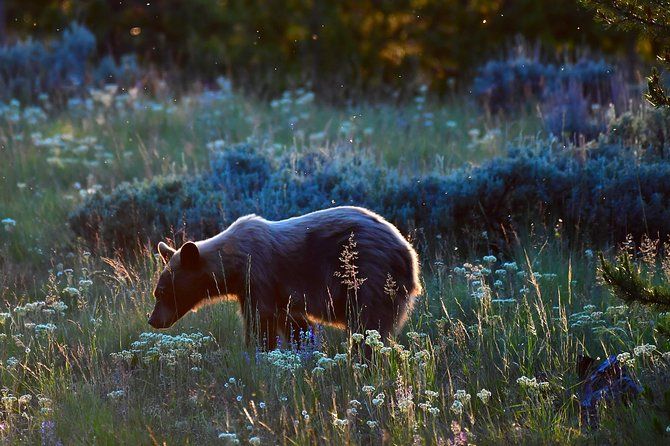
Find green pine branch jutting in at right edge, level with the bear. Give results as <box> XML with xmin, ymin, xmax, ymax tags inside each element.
<box><xmin>599</xmin><ymin>252</ymin><xmax>670</xmax><ymax>311</ymax></box>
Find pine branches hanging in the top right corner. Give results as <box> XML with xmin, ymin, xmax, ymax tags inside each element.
<box><xmin>580</xmin><ymin>0</ymin><xmax>670</xmax><ymax>107</ymax></box>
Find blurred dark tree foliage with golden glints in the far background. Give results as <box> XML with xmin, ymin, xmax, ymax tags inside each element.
<box><xmin>0</xmin><ymin>0</ymin><xmax>631</xmax><ymax>97</ymax></box>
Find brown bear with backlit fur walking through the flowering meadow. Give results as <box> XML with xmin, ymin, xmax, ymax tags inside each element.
<box><xmin>148</xmin><ymin>206</ymin><xmax>422</xmax><ymax>350</ymax></box>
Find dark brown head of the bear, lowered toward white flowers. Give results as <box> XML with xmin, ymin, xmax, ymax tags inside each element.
<box><xmin>149</xmin><ymin>242</ymin><xmax>217</xmax><ymax>328</ymax></box>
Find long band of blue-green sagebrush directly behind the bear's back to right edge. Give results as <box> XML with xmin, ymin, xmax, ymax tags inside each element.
<box><xmin>70</xmin><ymin>145</ymin><xmax>670</xmax><ymax>251</ymax></box>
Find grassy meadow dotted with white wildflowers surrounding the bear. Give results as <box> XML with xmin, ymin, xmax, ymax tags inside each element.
<box><xmin>0</xmin><ymin>67</ymin><xmax>670</xmax><ymax>445</ymax></box>
